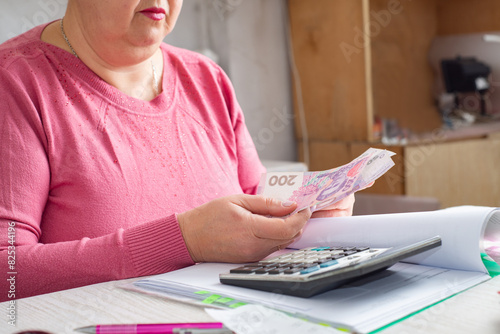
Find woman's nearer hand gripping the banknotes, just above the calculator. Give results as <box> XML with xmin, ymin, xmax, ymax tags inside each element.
<box><xmin>177</xmin><ymin>195</ymin><xmax>311</xmax><ymax>263</ymax></box>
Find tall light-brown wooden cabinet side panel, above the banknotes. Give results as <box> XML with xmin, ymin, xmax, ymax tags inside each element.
<box><xmin>289</xmin><ymin>0</ymin><xmax>371</xmax><ymax>141</ymax></box>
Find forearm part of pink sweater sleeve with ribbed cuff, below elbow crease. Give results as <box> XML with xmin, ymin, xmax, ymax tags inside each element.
<box><xmin>0</xmin><ymin>215</ymin><xmax>194</xmax><ymax>301</ymax></box>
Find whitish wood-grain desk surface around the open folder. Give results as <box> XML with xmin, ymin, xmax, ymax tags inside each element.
<box><xmin>0</xmin><ymin>276</ymin><xmax>500</xmax><ymax>334</ymax></box>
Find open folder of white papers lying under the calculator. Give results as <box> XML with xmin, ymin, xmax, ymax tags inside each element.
<box><xmin>130</xmin><ymin>206</ymin><xmax>500</xmax><ymax>333</ymax></box>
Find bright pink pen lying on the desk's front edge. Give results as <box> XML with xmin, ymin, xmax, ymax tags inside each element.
<box><xmin>75</xmin><ymin>322</ymin><xmax>227</xmax><ymax>334</ymax></box>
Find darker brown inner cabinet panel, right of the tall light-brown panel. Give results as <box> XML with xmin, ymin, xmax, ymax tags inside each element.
<box><xmin>370</xmin><ymin>0</ymin><xmax>441</xmax><ymax>132</ymax></box>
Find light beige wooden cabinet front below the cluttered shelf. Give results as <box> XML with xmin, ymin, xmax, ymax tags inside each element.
<box><xmin>405</xmin><ymin>137</ymin><xmax>500</xmax><ymax>207</ymax></box>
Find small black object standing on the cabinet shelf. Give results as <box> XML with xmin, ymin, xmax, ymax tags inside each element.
<box><xmin>441</xmin><ymin>57</ymin><xmax>491</xmax><ymax>116</ymax></box>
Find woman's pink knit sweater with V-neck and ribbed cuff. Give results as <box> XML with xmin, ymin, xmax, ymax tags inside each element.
<box><xmin>0</xmin><ymin>26</ymin><xmax>264</xmax><ymax>301</ymax></box>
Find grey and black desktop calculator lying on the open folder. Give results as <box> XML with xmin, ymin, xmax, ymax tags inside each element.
<box><xmin>219</xmin><ymin>236</ymin><xmax>441</xmax><ymax>297</ymax></box>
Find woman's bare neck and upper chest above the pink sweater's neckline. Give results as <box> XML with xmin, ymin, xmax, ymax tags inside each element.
<box><xmin>41</xmin><ymin>20</ymin><xmax>163</xmax><ymax>101</ymax></box>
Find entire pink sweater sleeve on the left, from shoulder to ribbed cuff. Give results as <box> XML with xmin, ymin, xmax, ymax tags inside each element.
<box><xmin>0</xmin><ymin>69</ymin><xmax>193</xmax><ymax>301</ymax></box>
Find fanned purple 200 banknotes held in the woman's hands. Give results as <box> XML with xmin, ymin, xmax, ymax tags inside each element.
<box><xmin>257</xmin><ymin>148</ymin><xmax>395</xmax><ymax>214</ymax></box>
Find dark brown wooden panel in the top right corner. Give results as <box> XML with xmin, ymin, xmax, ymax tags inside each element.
<box><xmin>437</xmin><ymin>0</ymin><xmax>500</xmax><ymax>35</ymax></box>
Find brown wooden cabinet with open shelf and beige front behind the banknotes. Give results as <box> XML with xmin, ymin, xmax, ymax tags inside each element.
<box><xmin>289</xmin><ymin>0</ymin><xmax>500</xmax><ymax>207</ymax></box>
